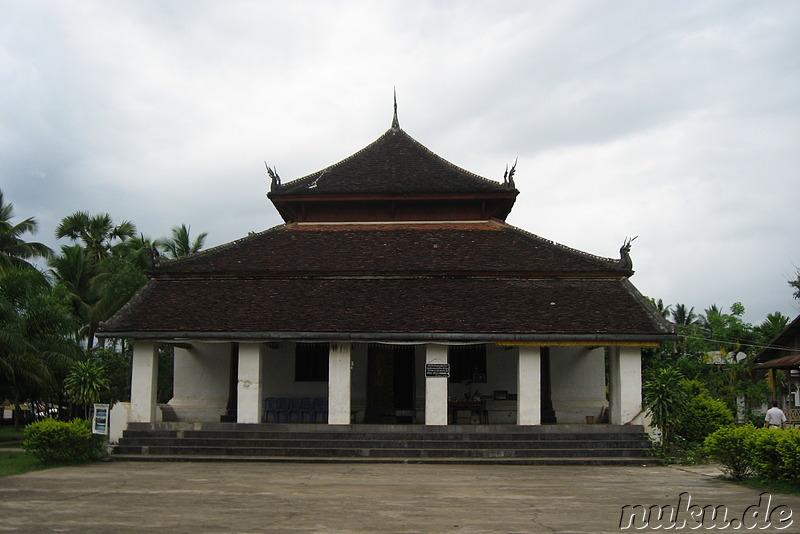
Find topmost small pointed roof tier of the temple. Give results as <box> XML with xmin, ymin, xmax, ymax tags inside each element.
<box><xmin>269</xmin><ymin>126</ymin><xmax>519</xmax><ymax>222</ymax></box>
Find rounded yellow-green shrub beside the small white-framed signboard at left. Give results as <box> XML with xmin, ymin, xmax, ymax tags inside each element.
<box><xmin>22</xmin><ymin>419</ymin><xmax>105</xmax><ymax>464</ymax></box>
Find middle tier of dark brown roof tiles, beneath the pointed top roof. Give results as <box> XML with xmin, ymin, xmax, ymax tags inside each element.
<box><xmin>155</xmin><ymin>221</ymin><xmax>632</xmax><ymax>276</ymax></box>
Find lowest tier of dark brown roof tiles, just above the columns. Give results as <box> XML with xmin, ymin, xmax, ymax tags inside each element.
<box><xmin>102</xmin><ymin>278</ymin><xmax>670</xmax><ymax>337</ymax></box>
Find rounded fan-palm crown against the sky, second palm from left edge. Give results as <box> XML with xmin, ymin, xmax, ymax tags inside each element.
<box><xmin>56</xmin><ymin>211</ymin><xmax>136</xmax><ymax>263</ymax></box>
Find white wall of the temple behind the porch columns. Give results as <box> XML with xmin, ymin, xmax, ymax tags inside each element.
<box><xmin>159</xmin><ymin>343</ymin><xmax>624</xmax><ymax>423</ymax></box>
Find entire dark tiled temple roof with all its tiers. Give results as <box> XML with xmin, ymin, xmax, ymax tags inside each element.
<box><xmin>101</xmin><ymin>115</ymin><xmax>673</xmax><ymax>344</ymax></box>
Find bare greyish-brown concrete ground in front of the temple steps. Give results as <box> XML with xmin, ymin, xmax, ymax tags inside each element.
<box><xmin>0</xmin><ymin>462</ymin><xmax>800</xmax><ymax>534</ymax></box>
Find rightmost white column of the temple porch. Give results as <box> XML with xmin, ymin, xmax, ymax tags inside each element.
<box><xmin>608</xmin><ymin>347</ymin><xmax>642</xmax><ymax>425</ymax></box>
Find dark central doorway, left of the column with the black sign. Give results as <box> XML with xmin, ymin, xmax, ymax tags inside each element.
<box><xmin>364</xmin><ymin>345</ymin><xmax>416</xmax><ymax>424</ymax></box>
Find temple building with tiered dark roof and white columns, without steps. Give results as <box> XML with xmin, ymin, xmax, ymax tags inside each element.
<box><xmin>99</xmin><ymin>107</ymin><xmax>674</xmax><ymax>434</ymax></box>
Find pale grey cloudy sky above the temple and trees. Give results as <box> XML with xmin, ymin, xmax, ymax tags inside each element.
<box><xmin>0</xmin><ymin>0</ymin><xmax>800</xmax><ymax>323</ymax></box>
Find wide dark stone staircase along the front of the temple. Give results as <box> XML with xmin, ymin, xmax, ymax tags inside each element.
<box><xmin>113</xmin><ymin>422</ymin><xmax>653</xmax><ymax>465</ymax></box>
